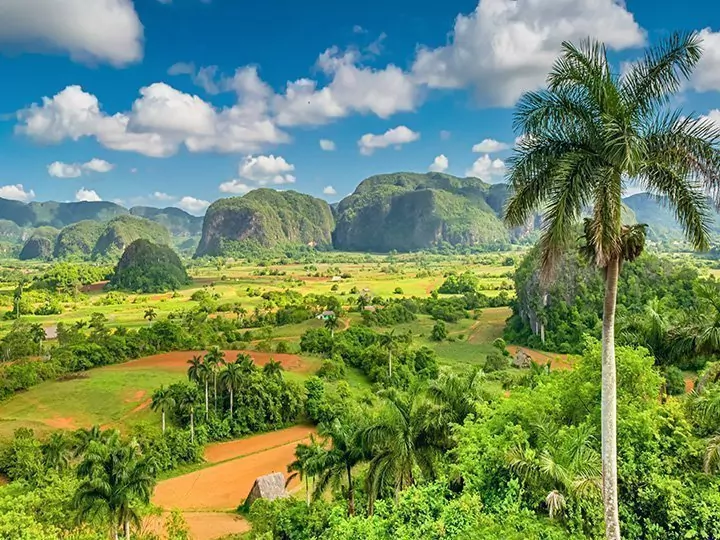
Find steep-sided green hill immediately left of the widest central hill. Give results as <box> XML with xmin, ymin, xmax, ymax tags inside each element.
<box><xmin>196</xmin><ymin>188</ymin><xmax>334</xmax><ymax>256</ymax></box>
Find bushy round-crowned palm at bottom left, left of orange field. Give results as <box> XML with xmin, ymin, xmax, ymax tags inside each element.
<box><xmin>74</xmin><ymin>441</ymin><xmax>155</xmax><ymax>540</ymax></box>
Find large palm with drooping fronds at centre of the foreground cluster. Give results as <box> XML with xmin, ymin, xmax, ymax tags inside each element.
<box><xmin>362</xmin><ymin>389</ymin><xmax>445</xmax><ymax>513</ymax></box>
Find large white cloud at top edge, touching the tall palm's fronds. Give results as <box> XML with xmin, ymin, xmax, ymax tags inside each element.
<box><xmin>412</xmin><ymin>0</ymin><xmax>645</xmax><ymax>107</ymax></box>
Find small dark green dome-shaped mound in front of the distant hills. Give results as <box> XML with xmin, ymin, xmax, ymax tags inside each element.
<box><xmin>108</xmin><ymin>239</ymin><xmax>189</xmax><ymax>293</ymax></box>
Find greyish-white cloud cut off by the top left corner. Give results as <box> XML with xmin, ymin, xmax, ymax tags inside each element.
<box><xmin>0</xmin><ymin>0</ymin><xmax>143</xmax><ymax>66</ymax></box>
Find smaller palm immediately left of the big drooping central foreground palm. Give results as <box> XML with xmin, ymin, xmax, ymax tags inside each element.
<box><xmin>313</xmin><ymin>418</ymin><xmax>364</xmax><ymax>516</ymax></box>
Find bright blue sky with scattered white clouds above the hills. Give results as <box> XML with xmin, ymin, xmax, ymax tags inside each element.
<box><xmin>0</xmin><ymin>0</ymin><xmax>720</xmax><ymax>218</ymax></box>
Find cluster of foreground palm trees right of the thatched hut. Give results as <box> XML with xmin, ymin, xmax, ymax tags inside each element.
<box><xmin>288</xmin><ymin>370</ymin><xmax>482</xmax><ymax>515</ymax></box>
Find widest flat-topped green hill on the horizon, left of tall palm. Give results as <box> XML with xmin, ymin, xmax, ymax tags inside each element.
<box><xmin>333</xmin><ymin>173</ymin><xmax>510</xmax><ymax>252</ymax></box>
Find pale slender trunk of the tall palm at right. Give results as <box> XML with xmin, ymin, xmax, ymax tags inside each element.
<box><xmin>601</xmin><ymin>259</ymin><xmax>620</xmax><ymax>540</ymax></box>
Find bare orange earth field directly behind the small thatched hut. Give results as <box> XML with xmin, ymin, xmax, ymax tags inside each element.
<box><xmin>152</xmin><ymin>442</ymin><xmax>308</xmax><ymax>511</ymax></box>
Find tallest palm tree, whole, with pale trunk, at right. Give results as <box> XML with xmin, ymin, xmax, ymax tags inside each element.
<box><xmin>505</xmin><ymin>34</ymin><xmax>720</xmax><ymax>540</ymax></box>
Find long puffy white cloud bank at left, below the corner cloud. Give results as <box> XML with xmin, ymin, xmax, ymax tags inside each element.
<box><xmin>15</xmin><ymin>83</ymin><xmax>289</xmax><ymax>157</ymax></box>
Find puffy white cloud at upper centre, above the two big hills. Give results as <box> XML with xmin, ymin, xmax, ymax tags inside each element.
<box><xmin>272</xmin><ymin>47</ymin><xmax>420</xmax><ymax>126</ymax></box>
